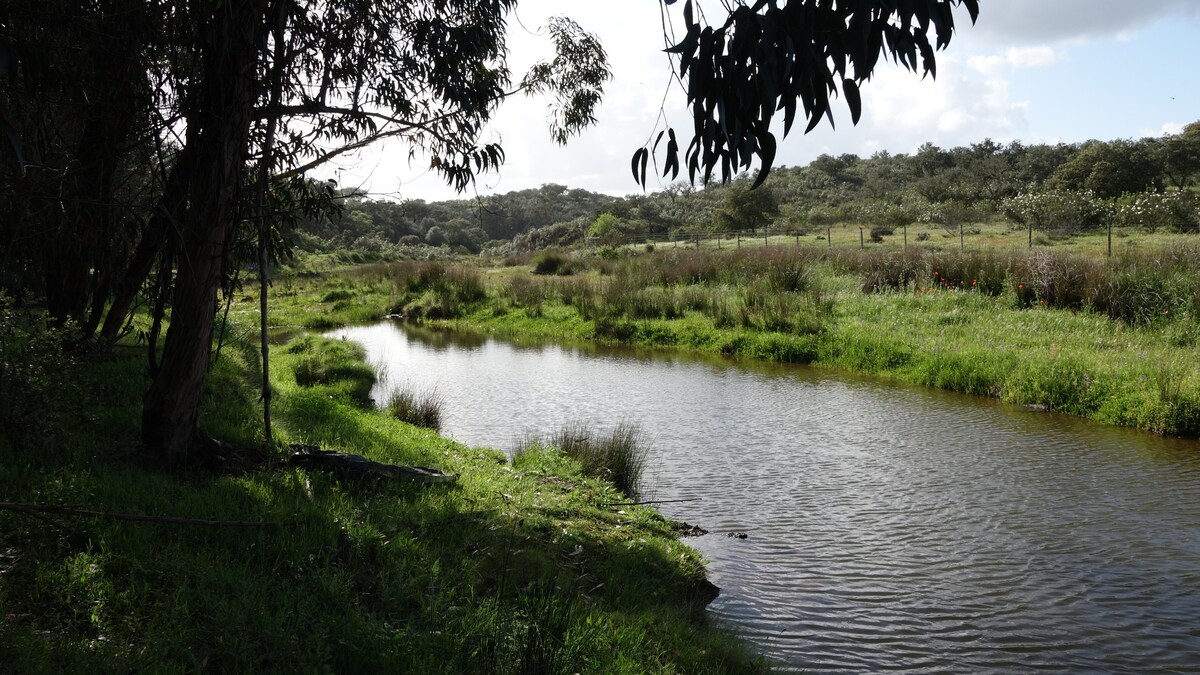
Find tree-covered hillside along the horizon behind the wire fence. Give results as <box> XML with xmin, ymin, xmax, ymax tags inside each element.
<box><xmin>314</xmin><ymin>123</ymin><xmax>1200</xmax><ymax>253</ymax></box>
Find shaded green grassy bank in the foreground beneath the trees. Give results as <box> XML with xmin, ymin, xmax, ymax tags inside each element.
<box><xmin>0</xmin><ymin>314</ymin><xmax>760</xmax><ymax>673</ymax></box>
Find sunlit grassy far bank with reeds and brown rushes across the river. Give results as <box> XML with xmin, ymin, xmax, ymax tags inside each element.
<box><xmin>262</xmin><ymin>245</ymin><xmax>1200</xmax><ymax>436</ymax></box>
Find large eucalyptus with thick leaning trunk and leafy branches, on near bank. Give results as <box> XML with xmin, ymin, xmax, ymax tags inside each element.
<box><xmin>143</xmin><ymin>0</ymin><xmax>608</xmax><ymax>461</ymax></box>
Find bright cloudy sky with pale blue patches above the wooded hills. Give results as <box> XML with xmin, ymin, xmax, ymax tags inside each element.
<box><xmin>318</xmin><ymin>0</ymin><xmax>1200</xmax><ymax>202</ymax></box>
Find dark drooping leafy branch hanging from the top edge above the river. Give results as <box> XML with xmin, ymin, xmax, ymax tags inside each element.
<box><xmin>631</xmin><ymin>0</ymin><xmax>979</xmax><ymax>187</ymax></box>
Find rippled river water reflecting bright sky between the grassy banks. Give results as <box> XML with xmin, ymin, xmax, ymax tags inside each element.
<box><xmin>335</xmin><ymin>323</ymin><xmax>1200</xmax><ymax>671</ymax></box>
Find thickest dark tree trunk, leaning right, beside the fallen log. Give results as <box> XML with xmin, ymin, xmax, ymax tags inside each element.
<box><xmin>142</xmin><ymin>0</ymin><xmax>264</xmax><ymax>464</ymax></box>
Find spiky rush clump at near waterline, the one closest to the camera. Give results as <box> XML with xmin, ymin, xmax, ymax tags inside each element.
<box><xmin>512</xmin><ymin>422</ymin><xmax>649</xmax><ymax>497</ymax></box>
